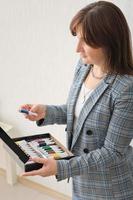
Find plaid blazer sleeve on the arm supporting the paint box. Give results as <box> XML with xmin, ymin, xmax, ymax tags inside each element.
<box><xmin>57</xmin><ymin>79</ymin><xmax>133</xmax><ymax>181</ymax></box>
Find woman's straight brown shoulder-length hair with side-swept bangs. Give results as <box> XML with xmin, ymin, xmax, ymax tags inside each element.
<box><xmin>70</xmin><ymin>1</ymin><xmax>133</xmax><ymax>74</ymax></box>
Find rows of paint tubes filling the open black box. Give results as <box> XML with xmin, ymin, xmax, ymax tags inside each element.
<box><xmin>15</xmin><ymin>134</ymin><xmax>69</xmax><ymax>159</ymax></box>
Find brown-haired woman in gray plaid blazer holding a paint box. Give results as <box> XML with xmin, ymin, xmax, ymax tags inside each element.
<box><xmin>21</xmin><ymin>1</ymin><xmax>133</xmax><ymax>200</ymax></box>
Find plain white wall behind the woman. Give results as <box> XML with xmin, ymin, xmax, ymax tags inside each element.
<box><xmin>0</xmin><ymin>0</ymin><xmax>133</xmax><ymax>197</ymax></box>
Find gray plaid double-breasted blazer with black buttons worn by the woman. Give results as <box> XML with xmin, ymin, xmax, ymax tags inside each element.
<box><xmin>40</xmin><ymin>61</ymin><xmax>133</xmax><ymax>200</ymax></box>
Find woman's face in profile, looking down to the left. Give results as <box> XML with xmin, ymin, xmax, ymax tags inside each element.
<box><xmin>76</xmin><ymin>33</ymin><xmax>105</xmax><ymax>67</ymax></box>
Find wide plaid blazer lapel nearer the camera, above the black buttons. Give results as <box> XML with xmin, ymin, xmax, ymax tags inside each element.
<box><xmin>71</xmin><ymin>75</ymin><xmax>116</xmax><ymax>149</ymax></box>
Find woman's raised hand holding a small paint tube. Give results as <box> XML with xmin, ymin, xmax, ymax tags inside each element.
<box><xmin>19</xmin><ymin>104</ymin><xmax>46</xmax><ymax>121</ymax></box>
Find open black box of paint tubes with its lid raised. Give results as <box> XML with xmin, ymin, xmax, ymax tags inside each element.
<box><xmin>0</xmin><ymin>127</ymin><xmax>74</xmax><ymax>172</ymax></box>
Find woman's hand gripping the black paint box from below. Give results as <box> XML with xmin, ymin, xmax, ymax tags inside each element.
<box><xmin>22</xmin><ymin>158</ymin><xmax>57</xmax><ymax>177</ymax></box>
